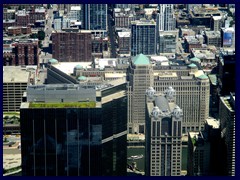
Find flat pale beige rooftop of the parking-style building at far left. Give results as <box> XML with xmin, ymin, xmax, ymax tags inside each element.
<box><xmin>3</xmin><ymin>66</ymin><xmax>30</xmax><ymax>83</ymax></box>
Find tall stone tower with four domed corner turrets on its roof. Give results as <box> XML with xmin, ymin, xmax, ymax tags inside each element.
<box><xmin>145</xmin><ymin>87</ymin><xmax>183</xmax><ymax>176</ymax></box>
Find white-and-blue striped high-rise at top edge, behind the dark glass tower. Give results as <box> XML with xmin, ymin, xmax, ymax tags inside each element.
<box><xmin>157</xmin><ymin>4</ymin><xmax>176</xmax><ymax>31</ymax></box>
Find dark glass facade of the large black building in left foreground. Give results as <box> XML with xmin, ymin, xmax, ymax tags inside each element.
<box><xmin>21</xmin><ymin>90</ymin><xmax>127</xmax><ymax>176</ymax></box>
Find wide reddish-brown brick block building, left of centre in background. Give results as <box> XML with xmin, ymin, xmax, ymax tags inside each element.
<box><xmin>52</xmin><ymin>30</ymin><xmax>92</xmax><ymax>62</ymax></box>
